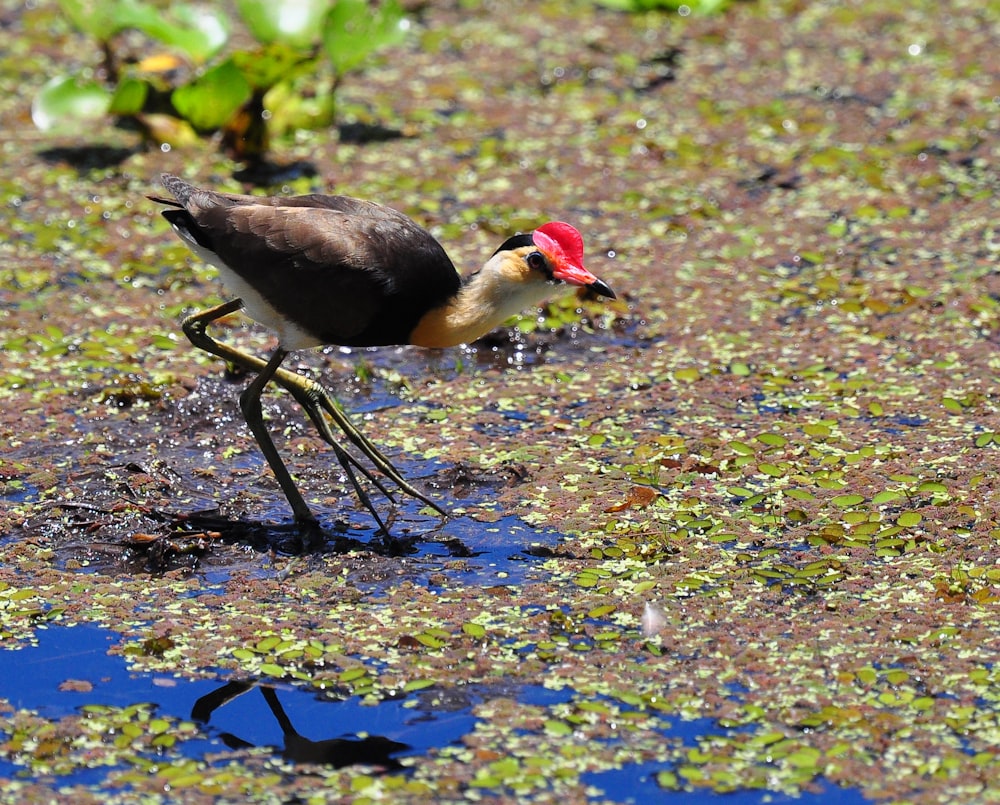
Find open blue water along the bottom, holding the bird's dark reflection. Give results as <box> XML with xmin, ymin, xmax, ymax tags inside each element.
<box><xmin>0</xmin><ymin>626</ymin><xmax>866</xmax><ymax>805</ymax></box>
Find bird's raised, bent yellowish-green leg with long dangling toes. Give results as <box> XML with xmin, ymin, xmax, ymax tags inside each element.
<box><xmin>183</xmin><ymin>299</ymin><xmax>447</xmax><ymax>528</ymax></box>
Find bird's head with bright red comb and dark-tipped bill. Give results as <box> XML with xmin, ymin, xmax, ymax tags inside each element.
<box><xmin>494</xmin><ymin>221</ymin><xmax>615</xmax><ymax>299</ymax></box>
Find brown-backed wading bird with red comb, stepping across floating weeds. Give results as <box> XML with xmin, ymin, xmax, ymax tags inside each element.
<box><xmin>148</xmin><ymin>173</ymin><xmax>615</xmax><ymax>534</ymax></box>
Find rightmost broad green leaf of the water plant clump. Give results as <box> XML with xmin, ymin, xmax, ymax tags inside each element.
<box><xmin>323</xmin><ymin>0</ymin><xmax>410</xmax><ymax>75</ymax></box>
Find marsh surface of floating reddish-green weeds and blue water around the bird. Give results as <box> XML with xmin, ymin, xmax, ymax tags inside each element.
<box><xmin>0</xmin><ymin>0</ymin><xmax>1000</xmax><ymax>803</ymax></box>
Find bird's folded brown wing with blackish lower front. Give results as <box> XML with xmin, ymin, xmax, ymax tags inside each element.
<box><xmin>164</xmin><ymin>180</ymin><xmax>461</xmax><ymax>346</ymax></box>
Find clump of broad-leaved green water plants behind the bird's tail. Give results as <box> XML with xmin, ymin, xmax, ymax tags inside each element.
<box><xmin>32</xmin><ymin>0</ymin><xmax>409</xmax><ymax>158</ymax></box>
